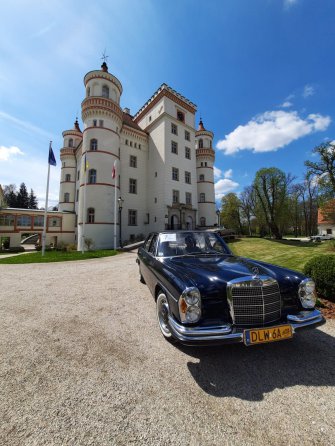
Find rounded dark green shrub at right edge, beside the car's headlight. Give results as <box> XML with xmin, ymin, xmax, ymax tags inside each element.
<box><xmin>304</xmin><ymin>255</ymin><xmax>335</xmax><ymax>302</ymax></box>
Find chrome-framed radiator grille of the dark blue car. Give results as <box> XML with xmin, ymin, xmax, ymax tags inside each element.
<box><xmin>228</xmin><ymin>278</ymin><xmax>281</xmax><ymax>325</ymax></box>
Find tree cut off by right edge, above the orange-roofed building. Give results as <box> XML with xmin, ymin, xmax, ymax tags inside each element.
<box><xmin>305</xmin><ymin>141</ymin><xmax>335</xmax><ymax>198</ymax></box>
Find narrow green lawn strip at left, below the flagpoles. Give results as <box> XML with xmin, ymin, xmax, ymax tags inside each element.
<box><xmin>0</xmin><ymin>249</ymin><xmax>117</xmax><ymax>265</ymax></box>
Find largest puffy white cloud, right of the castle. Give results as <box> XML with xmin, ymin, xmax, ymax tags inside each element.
<box><xmin>216</xmin><ymin>110</ymin><xmax>331</xmax><ymax>155</ymax></box>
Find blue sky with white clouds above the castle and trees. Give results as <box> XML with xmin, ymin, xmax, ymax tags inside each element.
<box><xmin>0</xmin><ymin>0</ymin><xmax>335</xmax><ymax>206</ymax></box>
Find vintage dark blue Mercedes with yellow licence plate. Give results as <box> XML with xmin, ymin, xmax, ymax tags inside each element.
<box><xmin>137</xmin><ymin>231</ymin><xmax>325</xmax><ymax>345</ymax></box>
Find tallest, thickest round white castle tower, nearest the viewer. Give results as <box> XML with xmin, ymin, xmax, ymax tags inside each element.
<box><xmin>78</xmin><ymin>62</ymin><xmax>123</xmax><ymax>250</ymax></box>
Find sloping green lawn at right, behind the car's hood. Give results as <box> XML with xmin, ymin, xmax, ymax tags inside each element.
<box><xmin>229</xmin><ymin>238</ymin><xmax>335</xmax><ymax>271</ymax></box>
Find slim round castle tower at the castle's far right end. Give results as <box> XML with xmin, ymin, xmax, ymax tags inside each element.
<box><xmin>195</xmin><ymin>118</ymin><xmax>217</xmax><ymax>227</ymax></box>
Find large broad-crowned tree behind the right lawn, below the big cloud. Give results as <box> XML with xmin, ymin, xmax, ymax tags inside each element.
<box><xmin>253</xmin><ymin>167</ymin><xmax>293</xmax><ymax>240</ymax></box>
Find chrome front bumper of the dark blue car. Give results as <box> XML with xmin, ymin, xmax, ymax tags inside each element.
<box><xmin>169</xmin><ymin>310</ymin><xmax>326</xmax><ymax>345</ymax></box>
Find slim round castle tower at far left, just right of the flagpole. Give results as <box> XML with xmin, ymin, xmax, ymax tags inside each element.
<box><xmin>59</xmin><ymin>119</ymin><xmax>83</xmax><ymax>212</ymax></box>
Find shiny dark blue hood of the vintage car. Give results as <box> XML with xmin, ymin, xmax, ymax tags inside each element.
<box><xmin>167</xmin><ymin>255</ymin><xmax>304</xmax><ymax>295</ymax></box>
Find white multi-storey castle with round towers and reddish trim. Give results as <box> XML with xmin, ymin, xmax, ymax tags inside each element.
<box><xmin>59</xmin><ymin>63</ymin><xmax>217</xmax><ymax>249</ymax></box>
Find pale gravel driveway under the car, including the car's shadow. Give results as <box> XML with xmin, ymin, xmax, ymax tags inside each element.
<box><xmin>0</xmin><ymin>253</ymin><xmax>335</xmax><ymax>446</ymax></box>
